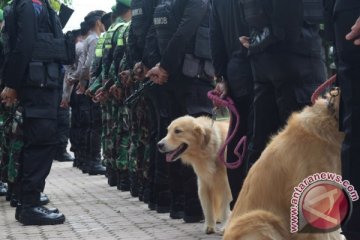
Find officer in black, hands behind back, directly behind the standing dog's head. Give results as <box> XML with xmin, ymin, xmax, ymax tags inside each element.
<box><xmin>147</xmin><ymin>0</ymin><xmax>214</xmax><ymax>222</ymax></box>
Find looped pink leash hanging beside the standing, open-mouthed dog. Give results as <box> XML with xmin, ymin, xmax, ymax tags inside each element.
<box><xmin>207</xmin><ymin>90</ymin><xmax>247</xmax><ymax>169</ymax></box>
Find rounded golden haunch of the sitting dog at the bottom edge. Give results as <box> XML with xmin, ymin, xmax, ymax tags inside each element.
<box><xmin>223</xmin><ymin>210</ymin><xmax>289</xmax><ymax>240</ymax></box>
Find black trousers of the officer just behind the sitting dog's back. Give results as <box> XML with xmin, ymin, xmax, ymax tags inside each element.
<box><xmin>248</xmin><ymin>50</ymin><xmax>326</xmax><ymax>168</ymax></box>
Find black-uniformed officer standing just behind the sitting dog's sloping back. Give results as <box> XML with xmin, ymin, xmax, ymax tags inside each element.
<box><xmin>240</xmin><ymin>0</ymin><xmax>326</xmax><ymax>168</ymax></box>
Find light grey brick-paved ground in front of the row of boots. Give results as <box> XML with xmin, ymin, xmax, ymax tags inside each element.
<box><xmin>0</xmin><ymin>162</ymin><xmax>221</xmax><ymax>240</ymax></box>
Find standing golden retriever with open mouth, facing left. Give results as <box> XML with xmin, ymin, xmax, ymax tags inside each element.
<box><xmin>158</xmin><ymin>116</ymin><xmax>232</xmax><ymax>234</ymax></box>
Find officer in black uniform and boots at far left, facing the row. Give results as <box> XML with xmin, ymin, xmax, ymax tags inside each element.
<box><xmin>1</xmin><ymin>0</ymin><xmax>65</xmax><ymax>225</ymax></box>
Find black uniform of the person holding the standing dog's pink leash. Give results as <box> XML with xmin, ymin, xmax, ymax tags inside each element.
<box><xmin>210</xmin><ymin>0</ymin><xmax>253</xmax><ymax>208</ymax></box>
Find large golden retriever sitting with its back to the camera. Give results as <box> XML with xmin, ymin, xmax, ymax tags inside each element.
<box><xmin>223</xmin><ymin>91</ymin><xmax>344</xmax><ymax>240</ymax></box>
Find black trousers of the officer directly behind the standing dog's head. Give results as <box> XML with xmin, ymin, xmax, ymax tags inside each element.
<box><xmin>156</xmin><ymin>77</ymin><xmax>212</xmax><ymax>216</ymax></box>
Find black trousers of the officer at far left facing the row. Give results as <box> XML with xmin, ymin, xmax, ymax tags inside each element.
<box><xmin>20</xmin><ymin>88</ymin><xmax>59</xmax><ymax>206</ymax></box>
